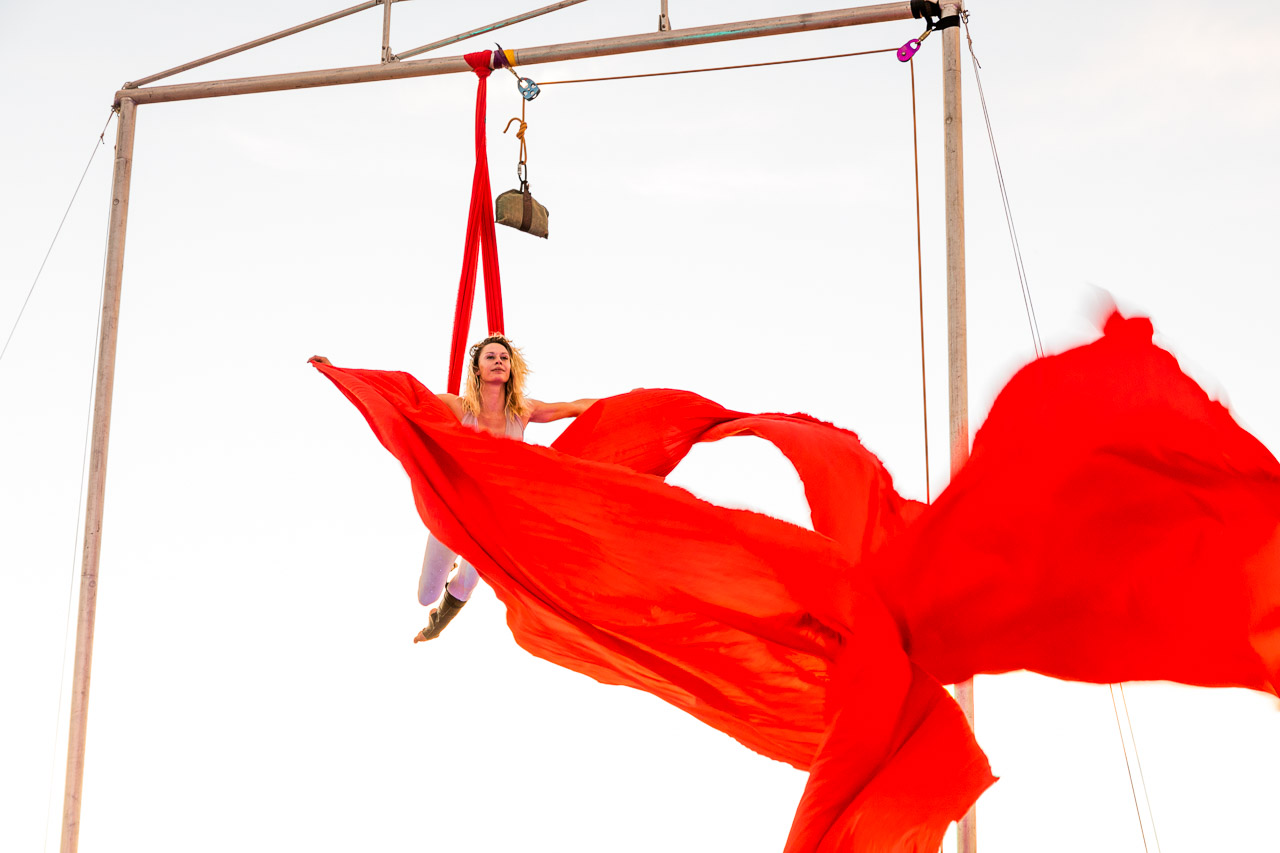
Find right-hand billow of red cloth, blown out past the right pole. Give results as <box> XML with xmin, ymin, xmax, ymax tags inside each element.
<box><xmin>868</xmin><ymin>314</ymin><xmax>1280</xmax><ymax>693</ymax></box>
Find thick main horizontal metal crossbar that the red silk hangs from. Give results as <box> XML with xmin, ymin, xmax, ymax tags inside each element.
<box><xmin>115</xmin><ymin>1</ymin><xmax>911</xmax><ymax>105</ymax></box>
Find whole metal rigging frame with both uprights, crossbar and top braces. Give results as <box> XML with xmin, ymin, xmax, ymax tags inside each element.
<box><xmin>60</xmin><ymin>0</ymin><xmax>977</xmax><ymax>853</ymax></box>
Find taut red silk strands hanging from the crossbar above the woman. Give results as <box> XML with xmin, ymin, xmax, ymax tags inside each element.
<box><xmin>448</xmin><ymin>50</ymin><xmax>504</xmax><ymax>394</ymax></box>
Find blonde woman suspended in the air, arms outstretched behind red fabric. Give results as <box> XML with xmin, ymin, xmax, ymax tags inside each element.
<box><xmin>311</xmin><ymin>334</ymin><xmax>595</xmax><ymax>643</ymax></box>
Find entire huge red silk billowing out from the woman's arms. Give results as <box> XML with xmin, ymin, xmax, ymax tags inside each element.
<box><xmin>309</xmin><ymin>318</ymin><xmax>1280</xmax><ymax>853</ymax></box>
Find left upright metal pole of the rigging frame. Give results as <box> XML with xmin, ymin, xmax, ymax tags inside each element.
<box><xmin>61</xmin><ymin>97</ymin><xmax>137</xmax><ymax>853</ymax></box>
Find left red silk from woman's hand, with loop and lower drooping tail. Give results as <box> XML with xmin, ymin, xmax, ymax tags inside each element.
<box><xmin>317</xmin><ymin>365</ymin><xmax>992</xmax><ymax>850</ymax></box>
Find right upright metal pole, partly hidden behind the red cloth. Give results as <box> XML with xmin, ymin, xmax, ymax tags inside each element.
<box><xmin>940</xmin><ymin>3</ymin><xmax>978</xmax><ymax>853</ymax></box>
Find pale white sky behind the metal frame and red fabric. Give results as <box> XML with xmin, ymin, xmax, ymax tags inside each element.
<box><xmin>0</xmin><ymin>0</ymin><xmax>1280</xmax><ymax>853</ymax></box>
